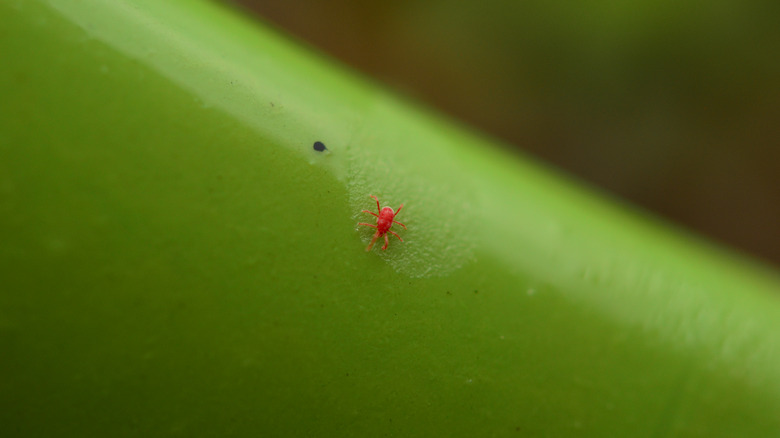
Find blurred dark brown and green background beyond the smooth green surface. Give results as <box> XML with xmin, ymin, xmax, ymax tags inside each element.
<box><xmin>217</xmin><ymin>0</ymin><xmax>780</xmax><ymax>266</ymax></box>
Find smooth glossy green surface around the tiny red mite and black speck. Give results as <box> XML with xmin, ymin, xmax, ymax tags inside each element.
<box><xmin>0</xmin><ymin>0</ymin><xmax>780</xmax><ymax>437</ymax></box>
